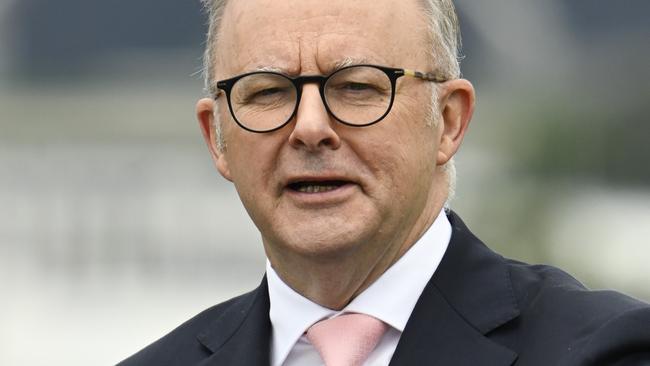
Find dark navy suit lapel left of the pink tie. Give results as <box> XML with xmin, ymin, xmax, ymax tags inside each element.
<box><xmin>197</xmin><ymin>277</ymin><xmax>271</xmax><ymax>366</ymax></box>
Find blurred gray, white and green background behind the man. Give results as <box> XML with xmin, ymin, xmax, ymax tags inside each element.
<box><xmin>0</xmin><ymin>0</ymin><xmax>650</xmax><ymax>365</ymax></box>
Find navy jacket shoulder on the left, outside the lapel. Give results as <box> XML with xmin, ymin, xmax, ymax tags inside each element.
<box><xmin>118</xmin><ymin>290</ymin><xmax>257</xmax><ymax>366</ymax></box>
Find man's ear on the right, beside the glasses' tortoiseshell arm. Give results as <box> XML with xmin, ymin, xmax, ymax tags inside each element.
<box><xmin>436</xmin><ymin>79</ymin><xmax>475</xmax><ymax>166</ymax></box>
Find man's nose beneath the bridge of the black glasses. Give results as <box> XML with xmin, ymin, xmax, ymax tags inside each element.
<box><xmin>289</xmin><ymin>84</ymin><xmax>341</xmax><ymax>151</ymax></box>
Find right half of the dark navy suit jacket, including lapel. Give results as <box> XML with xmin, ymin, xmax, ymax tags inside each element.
<box><xmin>391</xmin><ymin>213</ymin><xmax>650</xmax><ymax>366</ymax></box>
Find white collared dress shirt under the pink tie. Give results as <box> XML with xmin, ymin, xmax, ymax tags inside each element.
<box><xmin>266</xmin><ymin>210</ymin><xmax>451</xmax><ymax>366</ymax></box>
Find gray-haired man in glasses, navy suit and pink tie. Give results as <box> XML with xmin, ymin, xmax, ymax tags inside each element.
<box><xmin>122</xmin><ymin>0</ymin><xmax>650</xmax><ymax>366</ymax></box>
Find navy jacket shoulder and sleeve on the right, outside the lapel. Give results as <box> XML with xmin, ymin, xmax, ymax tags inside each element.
<box><xmin>506</xmin><ymin>260</ymin><xmax>650</xmax><ymax>365</ymax></box>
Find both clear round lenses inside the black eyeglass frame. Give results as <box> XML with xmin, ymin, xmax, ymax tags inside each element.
<box><xmin>230</xmin><ymin>66</ymin><xmax>392</xmax><ymax>131</ymax></box>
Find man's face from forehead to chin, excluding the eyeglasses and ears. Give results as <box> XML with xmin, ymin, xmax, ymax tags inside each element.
<box><xmin>205</xmin><ymin>0</ymin><xmax>454</xmax><ymax>262</ymax></box>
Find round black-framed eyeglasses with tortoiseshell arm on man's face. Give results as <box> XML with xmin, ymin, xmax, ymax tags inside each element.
<box><xmin>215</xmin><ymin>65</ymin><xmax>448</xmax><ymax>133</ymax></box>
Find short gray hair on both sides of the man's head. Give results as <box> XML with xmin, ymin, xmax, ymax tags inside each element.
<box><xmin>201</xmin><ymin>0</ymin><xmax>462</xmax><ymax>207</ymax></box>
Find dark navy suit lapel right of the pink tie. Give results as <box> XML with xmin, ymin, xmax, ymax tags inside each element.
<box><xmin>390</xmin><ymin>213</ymin><xmax>519</xmax><ymax>366</ymax></box>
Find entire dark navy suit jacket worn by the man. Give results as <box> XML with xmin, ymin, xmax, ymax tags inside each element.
<box><xmin>119</xmin><ymin>213</ymin><xmax>650</xmax><ymax>366</ymax></box>
